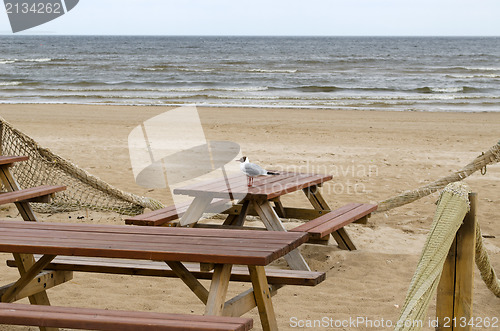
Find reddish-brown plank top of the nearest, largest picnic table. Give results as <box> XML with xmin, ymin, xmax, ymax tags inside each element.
<box><xmin>0</xmin><ymin>220</ymin><xmax>308</xmax><ymax>265</ymax></box>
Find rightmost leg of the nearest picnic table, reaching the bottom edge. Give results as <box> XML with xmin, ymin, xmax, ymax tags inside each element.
<box><xmin>248</xmin><ymin>266</ymin><xmax>278</xmax><ymax>330</ymax></box>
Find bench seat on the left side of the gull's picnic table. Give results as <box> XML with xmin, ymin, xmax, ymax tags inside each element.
<box><xmin>125</xmin><ymin>199</ymin><xmax>231</xmax><ymax>226</ymax></box>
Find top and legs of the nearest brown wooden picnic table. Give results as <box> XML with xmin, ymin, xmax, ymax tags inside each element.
<box><xmin>0</xmin><ymin>221</ymin><xmax>308</xmax><ymax>330</ymax></box>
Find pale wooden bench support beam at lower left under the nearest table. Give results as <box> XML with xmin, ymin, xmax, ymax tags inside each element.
<box><xmin>0</xmin><ymin>270</ymin><xmax>73</xmax><ymax>301</ymax></box>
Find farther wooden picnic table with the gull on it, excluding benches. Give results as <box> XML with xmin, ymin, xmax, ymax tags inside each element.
<box><xmin>173</xmin><ymin>171</ymin><xmax>336</xmax><ymax>270</ymax></box>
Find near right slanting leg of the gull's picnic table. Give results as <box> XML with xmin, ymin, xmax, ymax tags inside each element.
<box><xmin>252</xmin><ymin>200</ymin><xmax>311</xmax><ymax>271</ymax></box>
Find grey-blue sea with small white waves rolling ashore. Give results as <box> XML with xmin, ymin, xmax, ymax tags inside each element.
<box><xmin>0</xmin><ymin>35</ymin><xmax>500</xmax><ymax>112</ymax></box>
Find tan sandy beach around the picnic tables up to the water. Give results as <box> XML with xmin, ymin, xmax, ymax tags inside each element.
<box><xmin>0</xmin><ymin>104</ymin><xmax>500</xmax><ymax>331</ymax></box>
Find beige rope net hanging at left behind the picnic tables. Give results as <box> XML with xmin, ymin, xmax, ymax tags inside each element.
<box><xmin>0</xmin><ymin>117</ymin><xmax>163</xmax><ymax>215</ymax></box>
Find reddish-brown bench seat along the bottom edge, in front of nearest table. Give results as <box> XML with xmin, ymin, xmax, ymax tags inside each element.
<box><xmin>0</xmin><ymin>303</ymin><xmax>253</xmax><ymax>331</ymax></box>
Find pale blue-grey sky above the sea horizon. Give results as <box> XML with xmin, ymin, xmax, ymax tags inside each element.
<box><xmin>0</xmin><ymin>0</ymin><xmax>500</xmax><ymax>36</ymax></box>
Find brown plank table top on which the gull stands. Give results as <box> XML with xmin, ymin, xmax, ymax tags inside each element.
<box><xmin>174</xmin><ymin>172</ymin><xmax>333</xmax><ymax>200</ymax></box>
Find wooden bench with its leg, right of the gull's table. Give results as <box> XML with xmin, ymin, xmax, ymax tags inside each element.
<box><xmin>290</xmin><ymin>203</ymin><xmax>377</xmax><ymax>250</ymax></box>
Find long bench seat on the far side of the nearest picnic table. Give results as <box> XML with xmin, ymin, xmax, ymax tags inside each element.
<box><xmin>7</xmin><ymin>256</ymin><xmax>326</xmax><ymax>286</ymax></box>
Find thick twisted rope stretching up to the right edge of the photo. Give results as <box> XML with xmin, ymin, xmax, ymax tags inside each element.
<box><xmin>376</xmin><ymin>141</ymin><xmax>500</xmax><ymax>213</ymax></box>
